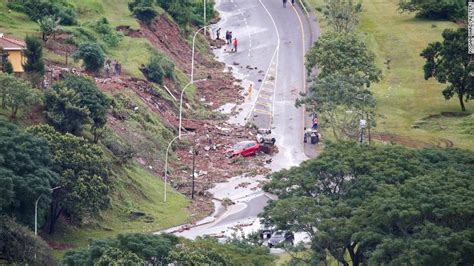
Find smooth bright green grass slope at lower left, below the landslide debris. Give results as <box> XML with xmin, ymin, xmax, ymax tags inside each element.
<box><xmin>47</xmin><ymin>165</ymin><xmax>189</xmax><ymax>259</ymax></box>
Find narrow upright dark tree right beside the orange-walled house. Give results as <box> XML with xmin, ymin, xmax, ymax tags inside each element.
<box><xmin>23</xmin><ymin>36</ymin><xmax>46</xmax><ymax>86</ymax></box>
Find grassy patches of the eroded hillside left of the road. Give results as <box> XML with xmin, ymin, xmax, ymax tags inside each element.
<box><xmin>0</xmin><ymin>0</ymin><xmax>194</xmax><ymax>258</ymax></box>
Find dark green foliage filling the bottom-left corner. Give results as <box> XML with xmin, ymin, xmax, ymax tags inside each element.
<box><xmin>0</xmin><ymin>215</ymin><xmax>55</xmax><ymax>265</ymax></box>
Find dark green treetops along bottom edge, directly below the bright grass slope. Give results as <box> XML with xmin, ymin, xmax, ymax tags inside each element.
<box><xmin>63</xmin><ymin>234</ymin><xmax>178</xmax><ymax>266</ymax></box>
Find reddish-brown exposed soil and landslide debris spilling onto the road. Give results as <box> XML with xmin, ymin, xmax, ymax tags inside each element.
<box><xmin>47</xmin><ymin>16</ymin><xmax>271</xmax><ymax>224</ymax></box>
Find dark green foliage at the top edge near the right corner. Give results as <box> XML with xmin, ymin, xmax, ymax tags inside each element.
<box><xmin>399</xmin><ymin>0</ymin><xmax>467</xmax><ymax>19</ymax></box>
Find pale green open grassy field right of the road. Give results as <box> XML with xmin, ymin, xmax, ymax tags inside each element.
<box><xmin>307</xmin><ymin>0</ymin><xmax>474</xmax><ymax>149</ymax></box>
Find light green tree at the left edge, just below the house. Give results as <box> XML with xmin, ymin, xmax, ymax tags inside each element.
<box><xmin>0</xmin><ymin>73</ymin><xmax>41</xmax><ymax>118</ymax></box>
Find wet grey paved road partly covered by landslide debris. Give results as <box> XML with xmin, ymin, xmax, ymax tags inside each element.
<box><xmin>161</xmin><ymin>0</ymin><xmax>318</xmax><ymax>239</ymax></box>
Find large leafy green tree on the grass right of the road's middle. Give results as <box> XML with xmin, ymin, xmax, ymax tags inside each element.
<box><xmin>302</xmin><ymin>32</ymin><xmax>381</xmax><ymax>139</ymax></box>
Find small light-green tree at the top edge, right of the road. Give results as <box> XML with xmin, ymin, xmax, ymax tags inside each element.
<box><xmin>323</xmin><ymin>0</ymin><xmax>362</xmax><ymax>33</ymax></box>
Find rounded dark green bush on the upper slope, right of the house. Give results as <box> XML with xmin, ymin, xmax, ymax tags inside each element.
<box><xmin>73</xmin><ymin>42</ymin><xmax>105</xmax><ymax>72</ymax></box>
